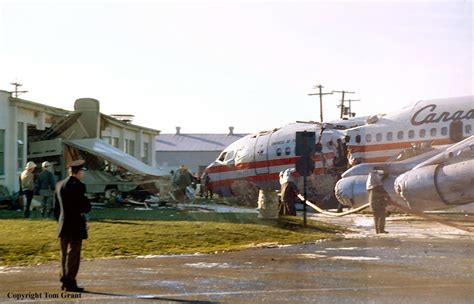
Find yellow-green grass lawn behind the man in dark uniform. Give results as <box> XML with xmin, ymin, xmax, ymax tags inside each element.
<box><xmin>0</xmin><ymin>208</ymin><xmax>341</xmax><ymax>266</ymax></box>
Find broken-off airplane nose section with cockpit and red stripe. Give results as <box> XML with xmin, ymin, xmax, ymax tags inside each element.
<box><xmin>206</xmin><ymin>123</ymin><xmax>344</xmax><ymax>196</ymax></box>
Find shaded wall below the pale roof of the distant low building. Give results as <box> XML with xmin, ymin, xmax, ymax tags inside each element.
<box><xmin>155</xmin><ymin>151</ymin><xmax>221</xmax><ymax>173</ymax></box>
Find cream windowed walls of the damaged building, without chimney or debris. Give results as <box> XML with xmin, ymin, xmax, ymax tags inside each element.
<box><xmin>0</xmin><ymin>90</ymin><xmax>158</xmax><ymax>192</ymax></box>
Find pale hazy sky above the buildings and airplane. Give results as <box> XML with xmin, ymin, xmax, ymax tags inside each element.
<box><xmin>0</xmin><ymin>0</ymin><xmax>474</xmax><ymax>133</ymax></box>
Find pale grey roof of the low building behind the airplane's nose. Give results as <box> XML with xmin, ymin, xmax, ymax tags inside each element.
<box><xmin>156</xmin><ymin>134</ymin><xmax>247</xmax><ymax>152</ymax></box>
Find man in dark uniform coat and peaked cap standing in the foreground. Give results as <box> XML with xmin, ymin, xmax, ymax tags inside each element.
<box><xmin>54</xmin><ymin>160</ymin><xmax>91</xmax><ymax>292</ymax></box>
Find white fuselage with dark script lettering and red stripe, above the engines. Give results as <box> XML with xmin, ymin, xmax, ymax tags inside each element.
<box><xmin>347</xmin><ymin>96</ymin><xmax>474</xmax><ymax>164</ymax></box>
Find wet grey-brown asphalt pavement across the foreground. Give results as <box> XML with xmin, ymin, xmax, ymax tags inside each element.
<box><xmin>0</xmin><ymin>215</ymin><xmax>474</xmax><ymax>303</ymax></box>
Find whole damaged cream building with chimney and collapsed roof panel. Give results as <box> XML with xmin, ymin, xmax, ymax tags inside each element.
<box><xmin>0</xmin><ymin>90</ymin><xmax>161</xmax><ymax>192</ymax></box>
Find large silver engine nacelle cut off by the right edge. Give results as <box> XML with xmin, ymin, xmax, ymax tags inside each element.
<box><xmin>394</xmin><ymin>159</ymin><xmax>474</xmax><ymax>210</ymax></box>
